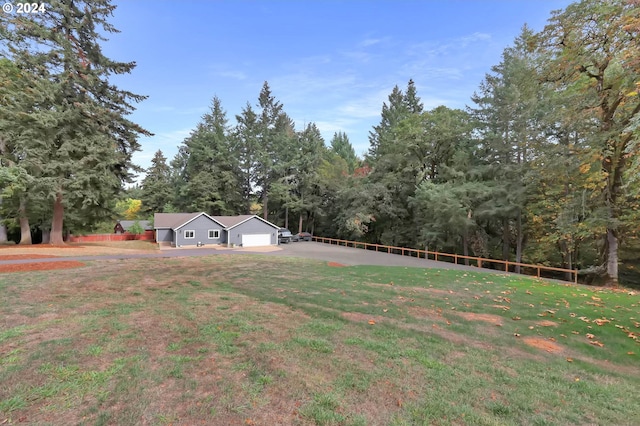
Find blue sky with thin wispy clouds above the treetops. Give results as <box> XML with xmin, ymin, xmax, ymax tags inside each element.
<box><xmin>103</xmin><ymin>0</ymin><xmax>571</xmax><ymax>176</ymax></box>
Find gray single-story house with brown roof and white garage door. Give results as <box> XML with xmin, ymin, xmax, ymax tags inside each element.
<box><xmin>153</xmin><ymin>212</ymin><xmax>279</xmax><ymax>247</ymax></box>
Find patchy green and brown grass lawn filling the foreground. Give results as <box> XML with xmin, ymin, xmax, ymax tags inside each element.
<box><xmin>0</xmin><ymin>255</ymin><xmax>640</xmax><ymax>425</ymax></box>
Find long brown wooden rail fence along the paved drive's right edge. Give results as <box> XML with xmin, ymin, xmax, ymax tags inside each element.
<box><xmin>313</xmin><ymin>237</ymin><xmax>578</xmax><ymax>284</ymax></box>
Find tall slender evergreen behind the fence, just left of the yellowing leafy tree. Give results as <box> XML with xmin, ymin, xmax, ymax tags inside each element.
<box><xmin>471</xmin><ymin>26</ymin><xmax>548</xmax><ymax>268</ymax></box>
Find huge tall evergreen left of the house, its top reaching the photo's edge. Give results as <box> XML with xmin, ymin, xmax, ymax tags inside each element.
<box><xmin>0</xmin><ymin>0</ymin><xmax>149</xmax><ymax>244</ymax></box>
